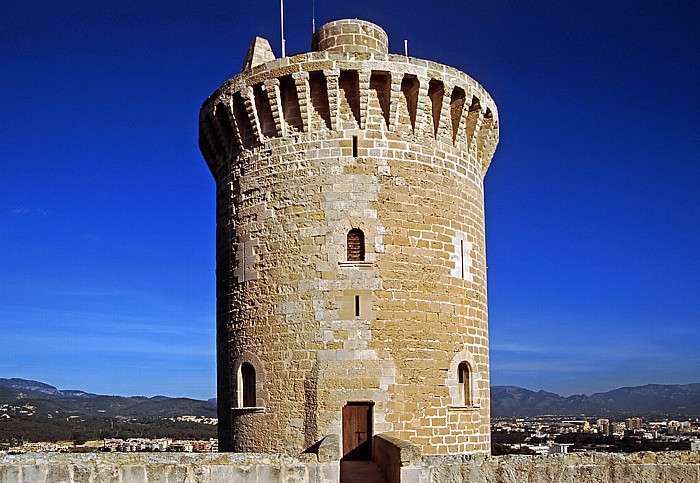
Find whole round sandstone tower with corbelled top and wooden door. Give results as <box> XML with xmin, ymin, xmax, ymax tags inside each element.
<box><xmin>199</xmin><ymin>20</ymin><xmax>498</xmax><ymax>458</ymax></box>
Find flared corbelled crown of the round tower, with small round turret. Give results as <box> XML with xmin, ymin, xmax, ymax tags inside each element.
<box><xmin>200</xmin><ymin>20</ymin><xmax>498</xmax><ymax>181</ymax></box>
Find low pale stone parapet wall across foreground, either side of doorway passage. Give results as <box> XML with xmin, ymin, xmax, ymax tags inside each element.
<box><xmin>0</xmin><ymin>451</ymin><xmax>700</xmax><ymax>483</ymax></box>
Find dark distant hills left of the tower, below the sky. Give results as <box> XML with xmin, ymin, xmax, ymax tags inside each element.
<box><xmin>0</xmin><ymin>378</ymin><xmax>216</xmax><ymax>418</ymax></box>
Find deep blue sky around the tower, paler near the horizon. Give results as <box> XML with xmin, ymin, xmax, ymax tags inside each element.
<box><xmin>0</xmin><ymin>0</ymin><xmax>700</xmax><ymax>398</ymax></box>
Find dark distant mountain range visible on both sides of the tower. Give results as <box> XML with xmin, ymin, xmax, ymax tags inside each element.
<box><xmin>0</xmin><ymin>378</ymin><xmax>700</xmax><ymax>418</ymax></box>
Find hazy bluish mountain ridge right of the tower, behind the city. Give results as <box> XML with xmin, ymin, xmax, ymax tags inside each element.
<box><xmin>491</xmin><ymin>384</ymin><xmax>700</xmax><ymax>417</ymax></box>
